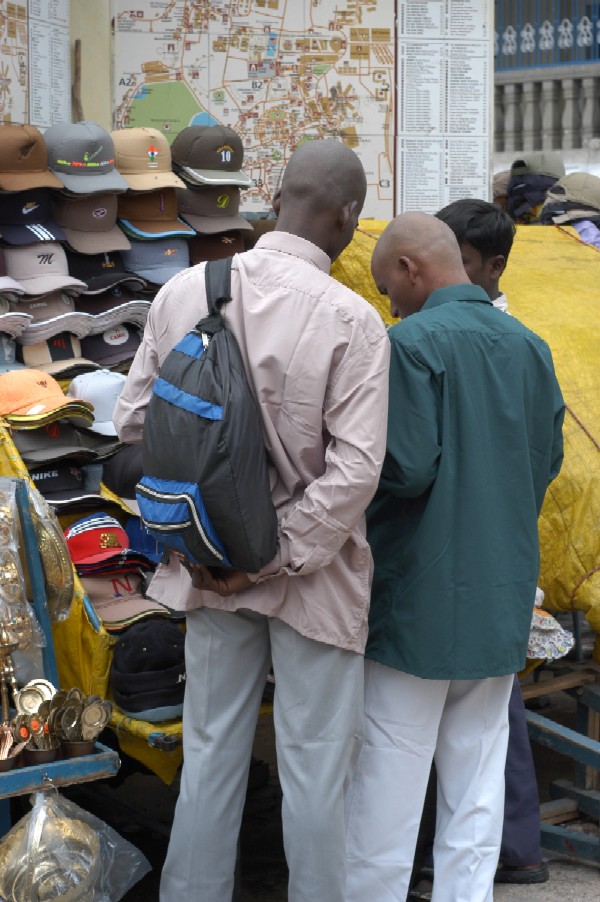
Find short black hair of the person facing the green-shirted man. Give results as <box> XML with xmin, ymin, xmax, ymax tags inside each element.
<box><xmin>435</xmin><ymin>197</ymin><xmax>515</xmax><ymax>260</ymax></box>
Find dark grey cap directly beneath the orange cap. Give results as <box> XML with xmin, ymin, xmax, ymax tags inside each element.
<box><xmin>12</xmin><ymin>420</ymin><xmax>121</xmax><ymax>467</ymax></box>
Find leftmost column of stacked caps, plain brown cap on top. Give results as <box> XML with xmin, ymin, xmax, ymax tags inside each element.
<box><xmin>0</xmin><ymin>125</ymin><xmax>94</xmax><ymax>376</ymax></box>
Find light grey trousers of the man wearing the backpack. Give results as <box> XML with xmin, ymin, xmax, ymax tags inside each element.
<box><xmin>160</xmin><ymin>608</ymin><xmax>364</xmax><ymax>902</ymax></box>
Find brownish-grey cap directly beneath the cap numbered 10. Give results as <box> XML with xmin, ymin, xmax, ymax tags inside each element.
<box><xmin>177</xmin><ymin>185</ymin><xmax>252</xmax><ymax>235</ymax></box>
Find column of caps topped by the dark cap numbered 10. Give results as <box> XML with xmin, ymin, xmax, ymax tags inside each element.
<box><xmin>171</xmin><ymin>125</ymin><xmax>252</xmax><ymax>264</ymax></box>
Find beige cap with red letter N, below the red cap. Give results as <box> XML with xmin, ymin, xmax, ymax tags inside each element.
<box><xmin>81</xmin><ymin>571</ymin><xmax>170</xmax><ymax>636</ymax></box>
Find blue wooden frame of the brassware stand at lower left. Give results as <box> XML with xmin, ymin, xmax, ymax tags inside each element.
<box><xmin>0</xmin><ymin>478</ymin><xmax>120</xmax><ymax>837</ymax></box>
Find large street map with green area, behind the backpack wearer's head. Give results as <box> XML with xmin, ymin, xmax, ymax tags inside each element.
<box><xmin>112</xmin><ymin>0</ymin><xmax>395</xmax><ymax>219</ymax></box>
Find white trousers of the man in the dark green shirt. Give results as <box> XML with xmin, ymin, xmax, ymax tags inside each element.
<box><xmin>346</xmin><ymin>661</ymin><xmax>513</xmax><ymax>902</ymax></box>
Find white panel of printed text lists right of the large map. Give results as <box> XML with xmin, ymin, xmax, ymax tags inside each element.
<box><xmin>395</xmin><ymin>0</ymin><xmax>493</xmax><ymax>213</ymax></box>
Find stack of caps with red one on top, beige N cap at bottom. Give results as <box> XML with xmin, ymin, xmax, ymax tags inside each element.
<box><xmin>65</xmin><ymin>512</ymin><xmax>170</xmax><ymax>632</ymax></box>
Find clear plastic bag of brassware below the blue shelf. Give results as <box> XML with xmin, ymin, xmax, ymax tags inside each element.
<box><xmin>0</xmin><ymin>789</ymin><xmax>151</xmax><ymax>902</ymax></box>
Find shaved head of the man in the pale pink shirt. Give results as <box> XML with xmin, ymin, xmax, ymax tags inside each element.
<box><xmin>277</xmin><ymin>140</ymin><xmax>367</xmax><ymax>259</ymax></box>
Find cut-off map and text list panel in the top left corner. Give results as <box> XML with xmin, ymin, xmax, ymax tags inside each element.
<box><xmin>0</xmin><ymin>0</ymin><xmax>71</xmax><ymax>129</ymax></box>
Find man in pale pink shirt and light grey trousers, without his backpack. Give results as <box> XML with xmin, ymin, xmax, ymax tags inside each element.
<box><xmin>114</xmin><ymin>141</ymin><xmax>389</xmax><ymax>902</ymax></box>
